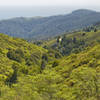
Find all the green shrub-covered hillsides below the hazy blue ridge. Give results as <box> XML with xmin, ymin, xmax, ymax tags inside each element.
<box><xmin>0</xmin><ymin>23</ymin><xmax>100</xmax><ymax>100</ymax></box>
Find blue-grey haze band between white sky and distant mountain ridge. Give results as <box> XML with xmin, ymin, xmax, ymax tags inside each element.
<box><xmin>0</xmin><ymin>6</ymin><xmax>100</xmax><ymax>20</ymax></box>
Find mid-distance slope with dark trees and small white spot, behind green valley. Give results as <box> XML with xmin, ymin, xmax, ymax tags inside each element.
<box><xmin>40</xmin><ymin>25</ymin><xmax>100</xmax><ymax>55</ymax></box>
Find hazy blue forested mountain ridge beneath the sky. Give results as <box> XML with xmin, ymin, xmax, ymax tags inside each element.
<box><xmin>0</xmin><ymin>9</ymin><xmax>100</xmax><ymax>39</ymax></box>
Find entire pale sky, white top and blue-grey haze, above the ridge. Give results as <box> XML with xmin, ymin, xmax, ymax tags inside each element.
<box><xmin>0</xmin><ymin>0</ymin><xmax>100</xmax><ymax>20</ymax></box>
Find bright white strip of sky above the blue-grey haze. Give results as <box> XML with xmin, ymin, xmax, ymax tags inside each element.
<box><xmin>0</xmin><ymin>0</ymin><xmax>100</xmax><ymax>6</ymax></box>
